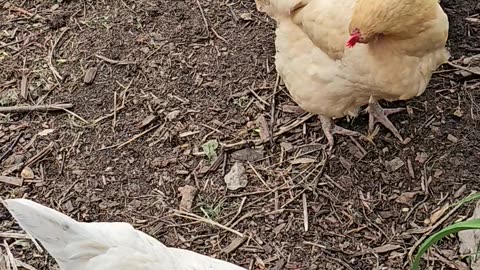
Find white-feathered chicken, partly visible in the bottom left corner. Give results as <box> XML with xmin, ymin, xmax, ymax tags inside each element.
<box><xmin>5</xmin><ymin>199</ymin><xmax>245</xmax><ymax>270</ymax></box>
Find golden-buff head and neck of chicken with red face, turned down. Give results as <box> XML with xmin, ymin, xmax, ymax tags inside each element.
<box><xmin>347</xmin><ymin>0</ymin><xmax>438</xmax><ymax>47</ymax></box>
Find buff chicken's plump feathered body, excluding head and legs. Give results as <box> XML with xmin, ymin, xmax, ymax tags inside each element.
<box><xmin>274</xmin><ymin>0</ymin><xmax>449</xmax><ymax>118</ymax></box>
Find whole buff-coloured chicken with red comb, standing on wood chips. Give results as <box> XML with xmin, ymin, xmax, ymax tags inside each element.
<box><xmin>255</xmin><ymin>0</ymin><xmax>449</xmax><ymax>149</ymax></box>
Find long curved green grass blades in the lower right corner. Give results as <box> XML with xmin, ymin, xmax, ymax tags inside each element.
<box><xmin>412</xmin><ymin>193</ymin><xmax>480</xmax><ymax>270</ymax></box>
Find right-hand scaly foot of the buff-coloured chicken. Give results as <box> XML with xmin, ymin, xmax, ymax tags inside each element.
<box><xmin>367</xmin><ymin>99</ymin><xmax>405</xmax><ymax>142</ymax></box>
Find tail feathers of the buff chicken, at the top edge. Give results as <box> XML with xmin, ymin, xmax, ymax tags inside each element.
<box><xmin>255</xmin><ymin>0</ymin><xmax>309</xmax><ymax>19</ymax></box>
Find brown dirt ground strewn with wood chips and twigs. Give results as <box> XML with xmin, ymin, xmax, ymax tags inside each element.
<box><xmin>0</xmin><ymin>0</ymin><xmax>480</xmax><ymax>269</ymax></box>
